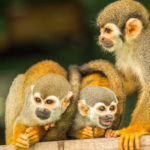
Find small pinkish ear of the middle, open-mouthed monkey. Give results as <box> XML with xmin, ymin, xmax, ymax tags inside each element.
<box><xmin>78</xmin><ymin>100</ymin><xmax>89</xmax><ymax>116</ymax></box>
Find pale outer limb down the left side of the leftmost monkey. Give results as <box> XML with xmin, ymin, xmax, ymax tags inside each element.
<box><xmin>5</xmin><ymin>74</ymin><xmax>24</xmax><ymax>144</ymax></box>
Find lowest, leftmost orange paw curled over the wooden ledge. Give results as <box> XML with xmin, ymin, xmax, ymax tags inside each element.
<box><xmin>15</xmin><ymin>134</ymin><xmax>29</xmax><ymax>150</ymax></box>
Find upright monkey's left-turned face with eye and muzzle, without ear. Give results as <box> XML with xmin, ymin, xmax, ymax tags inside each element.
<box><xmin>98</xmin><ymin>24</ymin><xmax>123</xmax><ymax>52</ymax></box>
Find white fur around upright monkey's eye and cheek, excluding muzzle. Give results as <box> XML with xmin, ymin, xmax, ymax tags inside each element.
<box><xmin>99</xmin><ymin>23</ymin><xmax>123</xmax><ymax>52</ymax></box>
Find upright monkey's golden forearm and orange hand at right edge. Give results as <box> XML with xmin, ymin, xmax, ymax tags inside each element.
<box><xmin>117</xmin><ymin>85</ymin><xmax>150</xmax><ymax>150</ymax></box>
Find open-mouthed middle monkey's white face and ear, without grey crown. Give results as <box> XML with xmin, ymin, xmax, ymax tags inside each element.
<box><xmin>78</xmin><ymin>100</ymin><xmax>117</xmax><ymax>129</ymax></box>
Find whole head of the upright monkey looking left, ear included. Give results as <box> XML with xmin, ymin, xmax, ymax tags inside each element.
<box><xmin>97</xmin><ymin>0</ymin><xmax>149</xmax><ymax>52</ymax></box>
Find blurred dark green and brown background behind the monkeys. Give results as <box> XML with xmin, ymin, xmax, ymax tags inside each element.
<box><xmin>0</xmin><ymin>0</ymin><xmax>150</xmax><ymax>144</ymax></box>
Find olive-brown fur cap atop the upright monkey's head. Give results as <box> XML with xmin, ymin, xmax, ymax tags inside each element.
<box><xmin>97</xmin><ymin>0</ymin><xmax>149</xmax><ymax>29</ymax></box>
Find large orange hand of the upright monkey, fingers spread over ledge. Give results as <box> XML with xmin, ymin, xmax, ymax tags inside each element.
<box><xmin>118</xmin><ymin>125</ymin><xmax>149</xmax><ymax>150</ymax></box>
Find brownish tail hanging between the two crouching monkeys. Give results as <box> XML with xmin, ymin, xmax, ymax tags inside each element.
<box><xmin>43</xmin><ymin>66</ymin><xmax>81</xmax><ymax>141</ymax></box>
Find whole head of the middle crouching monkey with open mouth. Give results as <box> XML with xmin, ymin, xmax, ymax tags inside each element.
<box><xmin>78</xmin><ymin>86</ymin><xmax>118</xmax><ymax>129</ymax></box>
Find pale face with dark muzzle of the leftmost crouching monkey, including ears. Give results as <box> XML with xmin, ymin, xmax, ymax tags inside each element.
<box><xmin>32</xmin><ymin>92</ymin><xmax>72</xmax><ymax>124</ymax></box>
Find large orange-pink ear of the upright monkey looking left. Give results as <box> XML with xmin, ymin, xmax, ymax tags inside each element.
<box><xmin>125</xmin><ymin>18</ymin><xmax>143</xmax><ymax>39</ymax></box>
